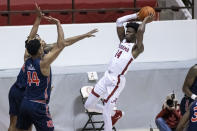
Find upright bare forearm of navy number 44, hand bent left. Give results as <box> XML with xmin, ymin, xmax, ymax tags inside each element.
<box><xmin>57</xmin><ymin>22</ymin><xmax>64</xmax><ymax>48</ymax></box>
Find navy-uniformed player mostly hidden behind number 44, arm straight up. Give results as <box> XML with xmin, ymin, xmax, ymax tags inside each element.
<box><xmin>8</xmin><ymin>3</ymin><xmax>44</xmax><ymax>131</ymax></box>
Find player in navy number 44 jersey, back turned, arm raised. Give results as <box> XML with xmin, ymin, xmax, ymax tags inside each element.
<box><xmin>17</xmin><ymin>16</ymin><xmax>97</xmax><ymax>131</ymax></box>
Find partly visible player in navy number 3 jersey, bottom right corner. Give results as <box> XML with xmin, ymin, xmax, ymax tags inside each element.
<box><xmin>176</xmin><ymin>100</ymin><xmax>197</xmax><ymax>131</ymax></box>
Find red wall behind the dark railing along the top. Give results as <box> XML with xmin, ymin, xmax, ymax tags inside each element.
<box><xmin>0</xmin><ymin>0</ymin><xmax>156</xmax><ymax>25</ymax></box>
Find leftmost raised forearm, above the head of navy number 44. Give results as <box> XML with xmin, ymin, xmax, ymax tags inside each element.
<box><xmin>29</xmin><ymin>16</ymin><xmax>41</xmax><ymax>39</ymax></box>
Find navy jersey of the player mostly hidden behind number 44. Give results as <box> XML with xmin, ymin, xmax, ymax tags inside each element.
<box><xmin>16</xmin><ymin>64</ymin><xmax>27</xmax><ymax>88</ymax></box>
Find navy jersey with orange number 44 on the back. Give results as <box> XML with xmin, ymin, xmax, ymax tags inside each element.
<box><xmin>25</xmin><ymin>58</ymin><xmax>51</xmax><ymax>104</ymax></box>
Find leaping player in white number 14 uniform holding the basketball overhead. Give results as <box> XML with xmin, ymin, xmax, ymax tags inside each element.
<box><xmin>85</xmin><ymin>13</ymin><xmax>153</xmax><ymax>131</ymax></box>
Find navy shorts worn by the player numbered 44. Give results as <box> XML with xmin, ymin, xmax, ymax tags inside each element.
<box><xmin>16</xmin><ymin>98</ymin><xmax>54</xmax><ymax>131</ymax></box>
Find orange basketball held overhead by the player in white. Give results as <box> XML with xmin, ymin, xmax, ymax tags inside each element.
<box><xmin>138</xmin><ymin>6</ymin><xmax>155</xmax><ymax>21</ymax></box>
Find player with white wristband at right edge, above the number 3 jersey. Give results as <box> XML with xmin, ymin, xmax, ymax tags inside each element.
<box><xmin>180</xmin><ymin>65</ymin><xmax>197</xmax><ymax>115</ymax></box>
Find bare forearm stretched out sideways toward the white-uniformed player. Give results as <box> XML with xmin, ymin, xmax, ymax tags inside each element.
<box><xmin>64</xmin><ymin>34</ymin><xmax>87</xmax><ymax>46</ymax></box>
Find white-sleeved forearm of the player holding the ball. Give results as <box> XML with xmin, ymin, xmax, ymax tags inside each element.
<box><xmin>116</xmin><ymin>13</ymin><xmax>137</xmax><ymax>27</ymax></box>
